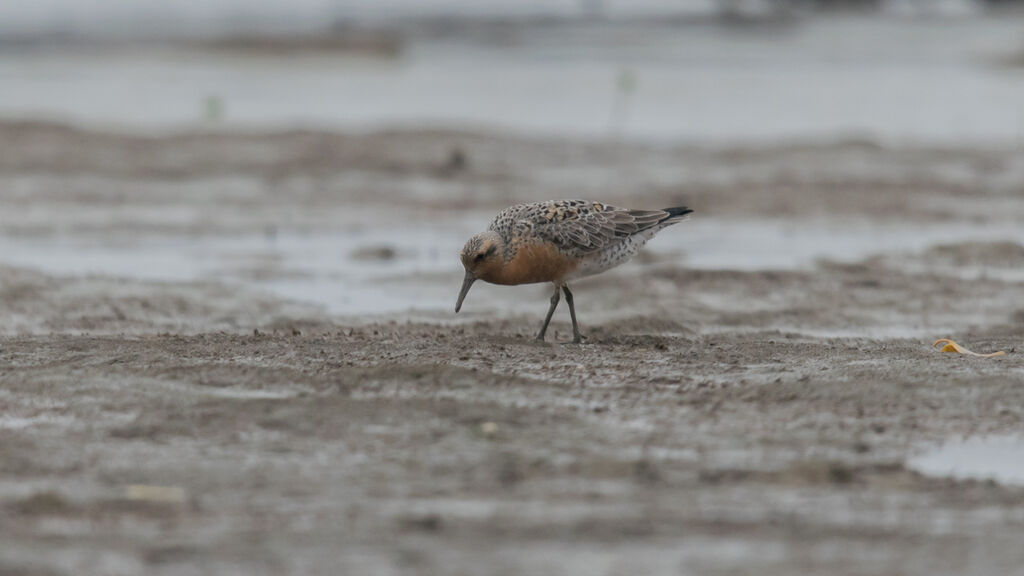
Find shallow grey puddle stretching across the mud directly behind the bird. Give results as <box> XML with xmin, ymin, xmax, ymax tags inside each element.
<box><xmin>0</xmin><ymin>214</ymin><xmax>1024</xmax><ymax>315</ymax></box>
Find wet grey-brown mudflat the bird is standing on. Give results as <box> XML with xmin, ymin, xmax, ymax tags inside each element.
<box><xmin>0</xmin><ymin>124</ymin><xmax>1024</xmax><ymax>575</ymax></box>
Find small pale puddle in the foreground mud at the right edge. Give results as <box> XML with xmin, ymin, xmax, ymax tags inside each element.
<box><xmin>907</xmin><ymin>435</ymin><xmax>1024</xmax><ymax>485</ymax></box>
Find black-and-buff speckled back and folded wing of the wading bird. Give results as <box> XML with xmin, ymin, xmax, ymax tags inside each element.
<box><xmin>492</xmin><ymin>200</ymin><xmax>670</xmax><ymax>256</ymax></box>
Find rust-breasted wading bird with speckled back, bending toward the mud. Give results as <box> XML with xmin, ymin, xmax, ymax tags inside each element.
<box><xmin>455</xmin><ymin>200</ymin><xmax>693</xmax><ymax>343</ymax></box>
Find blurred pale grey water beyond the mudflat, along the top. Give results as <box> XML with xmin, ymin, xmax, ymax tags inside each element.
<box><xmin>6</xmin><ymin>0</ymin><xmax>1024</xmax><ymax>142</ymax></box>
